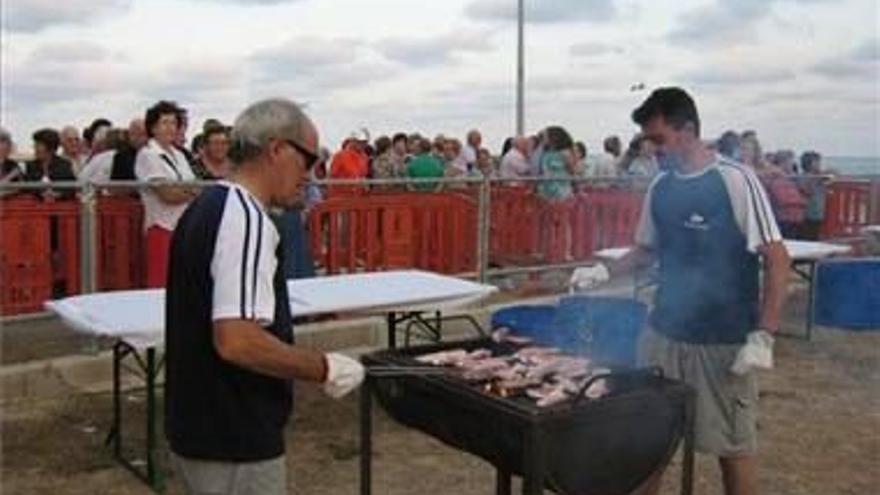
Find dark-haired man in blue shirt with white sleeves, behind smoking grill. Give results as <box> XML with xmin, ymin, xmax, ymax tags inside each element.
<box><xmin>574</xmin><ymin>88</ymin><xmax>789</xmax><ymax>495</ymax></box>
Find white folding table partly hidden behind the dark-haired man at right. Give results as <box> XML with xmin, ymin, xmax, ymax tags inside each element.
<box><xmin>594</xmin><ymin>239</ymin><xmax>852</xmax><ymax>340</ymax></box>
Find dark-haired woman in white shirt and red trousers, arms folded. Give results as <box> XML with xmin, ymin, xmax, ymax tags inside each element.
<box><xmin>134</xmin><ymin>101</ymin><xmax>198</xmax><ymax>287</ymax></box>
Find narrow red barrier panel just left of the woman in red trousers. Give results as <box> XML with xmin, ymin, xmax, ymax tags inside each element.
<box><xmin>96</xmin><ymin>196</ymin><xmax>144</xmax><ymax>290</ymax></box>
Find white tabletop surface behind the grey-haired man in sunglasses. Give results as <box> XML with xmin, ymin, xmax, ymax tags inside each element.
<box><xmin>46</xmin><ymin>271</ymin><xmax>497</xmax><ymax>348</ymax></box>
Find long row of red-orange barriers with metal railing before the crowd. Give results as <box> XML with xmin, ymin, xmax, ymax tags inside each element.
<box><xmin>0</xmin><ymin>178</ymin><xmax>880</xmax><ymax>316</ymax></box>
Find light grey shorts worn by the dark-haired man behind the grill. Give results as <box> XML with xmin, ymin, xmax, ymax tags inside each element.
<box><xmin>639</xmin><ymin>329</ymin><xmax>758</xmax><ymax>457</ymax></box>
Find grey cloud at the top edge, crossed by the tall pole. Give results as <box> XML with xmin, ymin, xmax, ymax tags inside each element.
<box><xmin>465</xmin><ymin>0</ymin><xmax>617</xmax><ymax>23</ymax></box>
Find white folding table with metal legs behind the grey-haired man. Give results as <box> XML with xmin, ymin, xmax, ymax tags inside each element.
<box><xmin>46</xmin><ymin>270</ymin><xmax>497</xmax><ymax>491</ymax></box>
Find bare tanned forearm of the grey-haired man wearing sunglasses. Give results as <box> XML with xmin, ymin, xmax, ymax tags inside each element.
<box><xmin>214</xmin><ymin>320</ymin><xmax>327</xmax><ymax>382</ymax></box>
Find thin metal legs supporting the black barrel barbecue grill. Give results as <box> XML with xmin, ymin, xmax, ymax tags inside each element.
<box><xmin>359</xmin><ymin>377</ymin><xmax>696</xmax><ymax>495</ymax></box>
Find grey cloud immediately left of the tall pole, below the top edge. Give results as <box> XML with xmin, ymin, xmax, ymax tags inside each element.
<box><xmin>375</xmin><ymin>32</ymin><xmax>493</xmax><ymax>67</ymax></box>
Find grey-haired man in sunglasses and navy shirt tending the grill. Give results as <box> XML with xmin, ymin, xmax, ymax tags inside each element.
<box><xmin>165</xmin><ymin>99</ymin><xmax>364</xmax><ymax>495</ymax></box>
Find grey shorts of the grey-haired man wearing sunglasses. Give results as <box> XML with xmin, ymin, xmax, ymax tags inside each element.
<box><xmin>171</xmin><ymin>452</ymin><xmax>287</xmax><ymax>495</ymax></box>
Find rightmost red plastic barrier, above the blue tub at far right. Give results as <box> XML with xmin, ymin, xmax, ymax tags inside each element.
<box><xmin>822</xmin><ymin>181</ymin><xmax>878</xmax><ymax>238</ymax></box>
